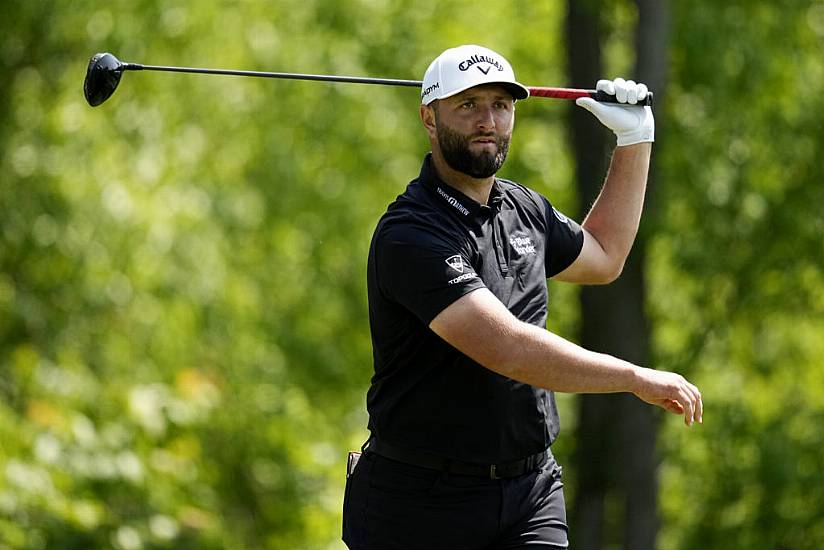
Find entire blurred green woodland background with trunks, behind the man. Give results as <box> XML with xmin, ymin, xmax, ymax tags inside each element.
<box><xmin>0</xmin><ymin>0</ymin><xmax>824</xmax><ymax>550</ymax></box>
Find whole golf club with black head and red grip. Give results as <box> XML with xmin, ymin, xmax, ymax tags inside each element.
<box><xmin>83</xmin><ymin>53</ymin><xmax>652</xmax><ymax>107</ymax></box>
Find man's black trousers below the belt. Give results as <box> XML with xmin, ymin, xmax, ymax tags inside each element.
<box><xmin>343</xmin><ymin>451</ymin><xmax>569</xmax><ymax>550</ymax></box>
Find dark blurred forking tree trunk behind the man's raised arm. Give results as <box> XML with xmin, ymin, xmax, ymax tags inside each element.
<box><xmin>566</xmin><ymin>0</ymin><xmax>667</xmax><ymax>550</ymax></box>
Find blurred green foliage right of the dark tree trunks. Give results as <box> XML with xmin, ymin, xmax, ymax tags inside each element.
<box><xmin>649</xmin><ymin>0</ymin><xmax>824</xmax><ymax>549</ymax></box>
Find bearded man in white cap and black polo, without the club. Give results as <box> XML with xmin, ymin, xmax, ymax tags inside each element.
<box><xmin>343</xmin><ymin>46</ymin><xmax>702</xmax><ymax>550</ymax></box>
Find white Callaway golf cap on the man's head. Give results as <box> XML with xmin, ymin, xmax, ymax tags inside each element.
<box><xmin>421</xmin><ymin>45</ymin><xmax>529</xmax><ymax>105</ymax></box>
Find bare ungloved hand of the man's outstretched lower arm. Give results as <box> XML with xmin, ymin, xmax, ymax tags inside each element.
<box><xmin>633</xmin><ymin>368</ymin><xmax>704</xmax><ymax>426</ymax></box>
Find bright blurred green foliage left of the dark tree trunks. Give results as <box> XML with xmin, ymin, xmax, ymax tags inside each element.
<box><xmin>0</xmin><ymin>1</ymin><xmax>567</xmax><ymax>549</ymax></box>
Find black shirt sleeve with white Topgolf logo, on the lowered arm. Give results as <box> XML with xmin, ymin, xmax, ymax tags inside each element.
<box><xmin>374</xmin><ymin>224</ymin><xmax>485</xmax><ymax>326</ymax></box>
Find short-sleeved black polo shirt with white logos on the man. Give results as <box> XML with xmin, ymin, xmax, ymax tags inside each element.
<box><xmin>367</xmin><ymin>155</ymin><xmax>583</xmax><ymax>464</ymax></box>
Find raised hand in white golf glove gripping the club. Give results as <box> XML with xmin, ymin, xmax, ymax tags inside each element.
<box><xmin>575</xmin><ymin>78</ymin><xmax>655</xmax><ymax>146</ymax></box>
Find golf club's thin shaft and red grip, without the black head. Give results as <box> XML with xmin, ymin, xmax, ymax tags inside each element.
<box><xmin>121</xmin><ymin>63</ymin><xmax>652</xmax><ymax>105</ymax></box>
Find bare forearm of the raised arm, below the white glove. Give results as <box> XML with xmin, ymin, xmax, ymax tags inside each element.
<box><xmin>583</xmin><ymin>143</ymin><xmax>652</xmax><ymax>271</ymax></box>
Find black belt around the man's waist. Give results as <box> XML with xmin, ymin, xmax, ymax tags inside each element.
<box><xmin>364</xmin><ymin>438</ymin><xmax>549</xmax><ymax>479</ymax></box>
